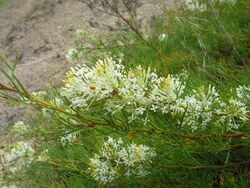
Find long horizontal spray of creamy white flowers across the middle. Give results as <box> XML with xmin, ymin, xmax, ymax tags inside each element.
<box><xmin>61</xmin><ymin>58</ymin><xmax>249</xmax><ymax>130</ymax></box>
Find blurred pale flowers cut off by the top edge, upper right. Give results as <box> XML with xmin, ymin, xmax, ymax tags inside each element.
<box><xmin>184</xmin><ymin>0</ymin><xmax>237</xmax><ymax>12</ymax></box>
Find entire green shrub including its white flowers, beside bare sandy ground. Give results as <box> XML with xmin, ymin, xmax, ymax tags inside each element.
<box><xmin>0</xmin><ymin>0</ymin><xmax>250</xmax><ymax>187</ymax></box>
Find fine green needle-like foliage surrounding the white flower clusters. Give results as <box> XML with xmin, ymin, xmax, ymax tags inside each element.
<box><xmin>0</xmin><ymin>0</ymin><xmax>250</xmax><ymax>188</ymax></box>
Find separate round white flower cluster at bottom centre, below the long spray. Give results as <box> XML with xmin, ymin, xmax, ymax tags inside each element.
<box><xmin>89</xmin><ymin>137</ymin><xmax>156</xmax><ymax>184</ymax></box>
